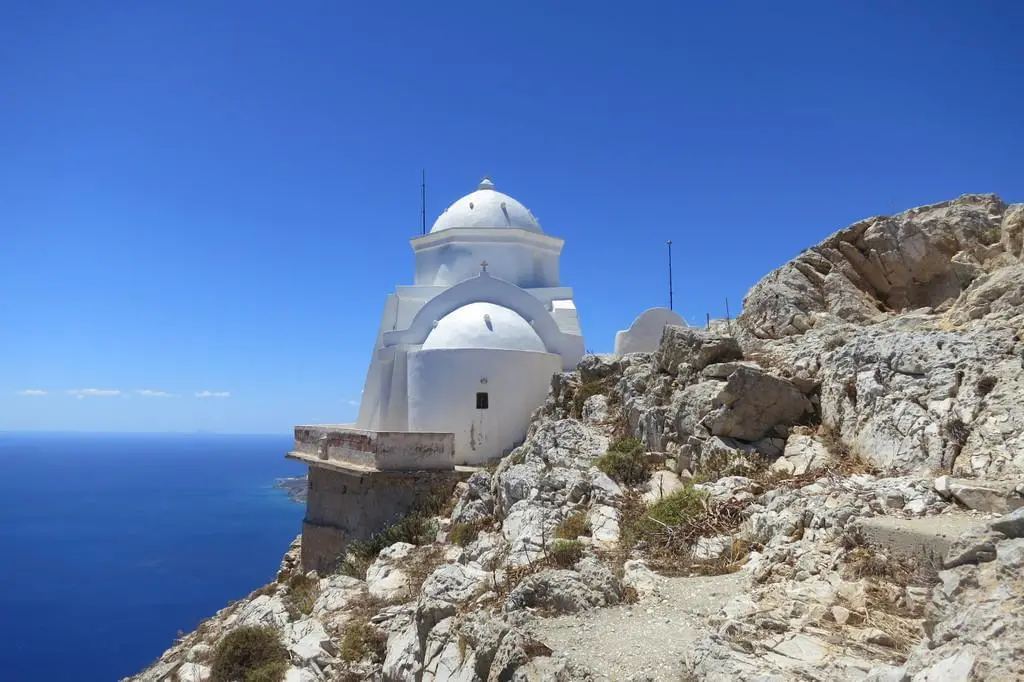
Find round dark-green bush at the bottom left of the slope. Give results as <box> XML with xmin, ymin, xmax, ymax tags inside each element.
<box><xmin>210</xmin><ymin>626</ymin><xmax>288</xmax><ymax>682</ymax></box>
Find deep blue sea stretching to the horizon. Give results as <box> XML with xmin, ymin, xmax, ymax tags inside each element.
<box><xmin>0</xmin><ymin>433</ymin><xmax>305</xmax><ymax>682</ymax></box>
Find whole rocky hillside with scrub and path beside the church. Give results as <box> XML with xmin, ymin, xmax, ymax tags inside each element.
<box><xmin>131</xmin><ymin>196</ymin><xmax>1024</xmax><ymax>682</ymax></box>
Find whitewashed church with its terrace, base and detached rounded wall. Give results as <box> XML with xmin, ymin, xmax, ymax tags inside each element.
<box><xmin>287</xmin><ymin>178</ymin><xmax>683</xmax><ymax>571</ymax></box>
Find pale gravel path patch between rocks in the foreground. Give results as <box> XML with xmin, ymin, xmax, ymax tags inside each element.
<box><xmin>532</xmin><ymin>573</ymin><xmax>742</xmax><ymax>682</ymax></box>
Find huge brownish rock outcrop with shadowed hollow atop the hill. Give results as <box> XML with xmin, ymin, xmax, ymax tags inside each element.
<box><xmin>737</xmin><ymin>195</ymin><xmax>1007</xmax><ymax>339</ymax></box>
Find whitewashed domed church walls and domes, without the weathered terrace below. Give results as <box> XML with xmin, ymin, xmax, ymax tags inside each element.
<box><xmin>355</xmin><ymin>178</ymin><xmax>584</xmax><ymax>465</ymax></box>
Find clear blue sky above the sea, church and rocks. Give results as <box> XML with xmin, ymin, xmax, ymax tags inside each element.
<box><xmin>0</xmin><ymin>0</ymin><xmax>1024</xmax><ymax>433</ymax></box>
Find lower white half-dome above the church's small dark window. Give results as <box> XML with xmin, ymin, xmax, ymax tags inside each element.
<box><xmin>423</xmin><ymin>302</ymin><xmax>547</xmax><ymax>352</ymax></box>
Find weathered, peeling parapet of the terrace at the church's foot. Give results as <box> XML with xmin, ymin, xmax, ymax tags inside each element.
<box><xmin>289</xmin><ymin>424</ymin><xmax>455</xmax><ymax>471</ymax></box>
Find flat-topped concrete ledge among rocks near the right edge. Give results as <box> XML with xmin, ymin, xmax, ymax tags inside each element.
<box><xmin>857</xmin><ymin>515</ymin><xmax>984</xmax><ymax>565</ymax></box>
